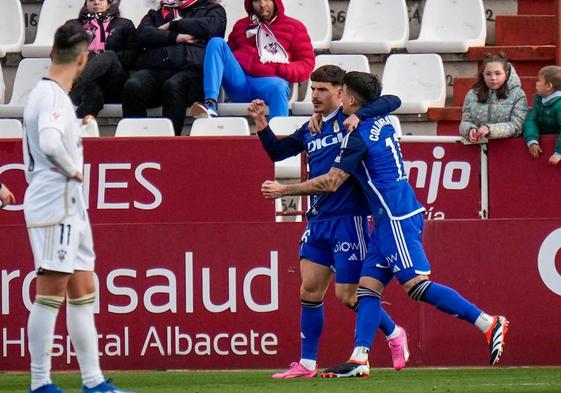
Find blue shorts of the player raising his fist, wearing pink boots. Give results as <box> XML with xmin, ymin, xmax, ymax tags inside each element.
<box><xmin>300</xmin><ymin>216</ymin><xmax>369</xmax><ymax>284</ymax></box>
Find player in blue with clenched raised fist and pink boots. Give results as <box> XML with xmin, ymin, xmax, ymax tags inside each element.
<box><xmin>252</xmin><ymin>65</ymin><xmax>409</xmax><ymax>379</ymax></box>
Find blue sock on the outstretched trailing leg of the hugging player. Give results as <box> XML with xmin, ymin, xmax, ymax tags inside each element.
<box><xmin>409</xmin><ymin>280</ymin><xmax>482</xmax><ymax>324</ymax></box>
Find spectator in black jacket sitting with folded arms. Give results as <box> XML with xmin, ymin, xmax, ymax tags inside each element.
<box><xmin>123</xmin><ymin>0</ymin><xmax>226</xmax><ymax>135</ymax></box>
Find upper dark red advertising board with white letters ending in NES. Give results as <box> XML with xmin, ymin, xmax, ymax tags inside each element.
<box><xmin>0</xmin><ymin>137</ymin><xmax>274</xmax><ymax>223</ymax></box>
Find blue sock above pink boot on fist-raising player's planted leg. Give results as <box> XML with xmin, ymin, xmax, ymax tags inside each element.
<box><xmin>300</xmin><ymin>300</ymin><xmax>324</xmax><ymax>360</ymax></box>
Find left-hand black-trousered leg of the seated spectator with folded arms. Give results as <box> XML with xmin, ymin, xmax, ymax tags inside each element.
<box><xmin>123</xmin><ymin>70</ymin><xmax>164</xmax><ymax>118</ymax></box>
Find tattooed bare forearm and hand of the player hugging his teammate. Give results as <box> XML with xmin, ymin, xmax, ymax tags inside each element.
<box><xmin>261</xmin><ymin>168</ymin><xmax>350</xmax><ymax>199</ymax></box>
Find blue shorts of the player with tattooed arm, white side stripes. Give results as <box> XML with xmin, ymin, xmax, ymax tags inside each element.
<box><xmin>362</xmin><ymin>213</ymin><xmax>430</xmax><ymax>286</ymax></box>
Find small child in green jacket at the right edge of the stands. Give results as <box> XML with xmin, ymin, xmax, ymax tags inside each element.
<box><xmin>524</xmin><ymin>66</ymin><xmax>561</xmax><ymax>165</ymax></box>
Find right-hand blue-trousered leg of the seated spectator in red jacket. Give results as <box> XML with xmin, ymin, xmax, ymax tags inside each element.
<box><xmin>249</xmin><ymin>77</ymin><xmax>290</xmax><ymax>120</ymax></box>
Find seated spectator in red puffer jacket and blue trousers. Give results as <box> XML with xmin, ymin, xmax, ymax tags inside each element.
<box><xmin>191</xmin><ymin>0</ymin><xmax>315</xmax><ymax>118</ymax></box>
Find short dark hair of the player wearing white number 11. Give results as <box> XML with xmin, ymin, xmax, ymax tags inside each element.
<box><xmin>51</xmin><ymin>24</ymin><xmax>90</xmax><ymax>64</ymax></box>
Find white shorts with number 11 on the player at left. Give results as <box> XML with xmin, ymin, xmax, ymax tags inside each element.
<box><xmin>27</xmin><ymin>213</ymin><xmax>95</xmax><ymax>273</ymax></box>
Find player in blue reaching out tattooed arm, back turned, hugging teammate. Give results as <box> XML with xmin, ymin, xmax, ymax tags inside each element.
<box><xmin>262</xmin><ymin>72</ymin><xmax>508</xmax><ymax>377</ymax></box>
